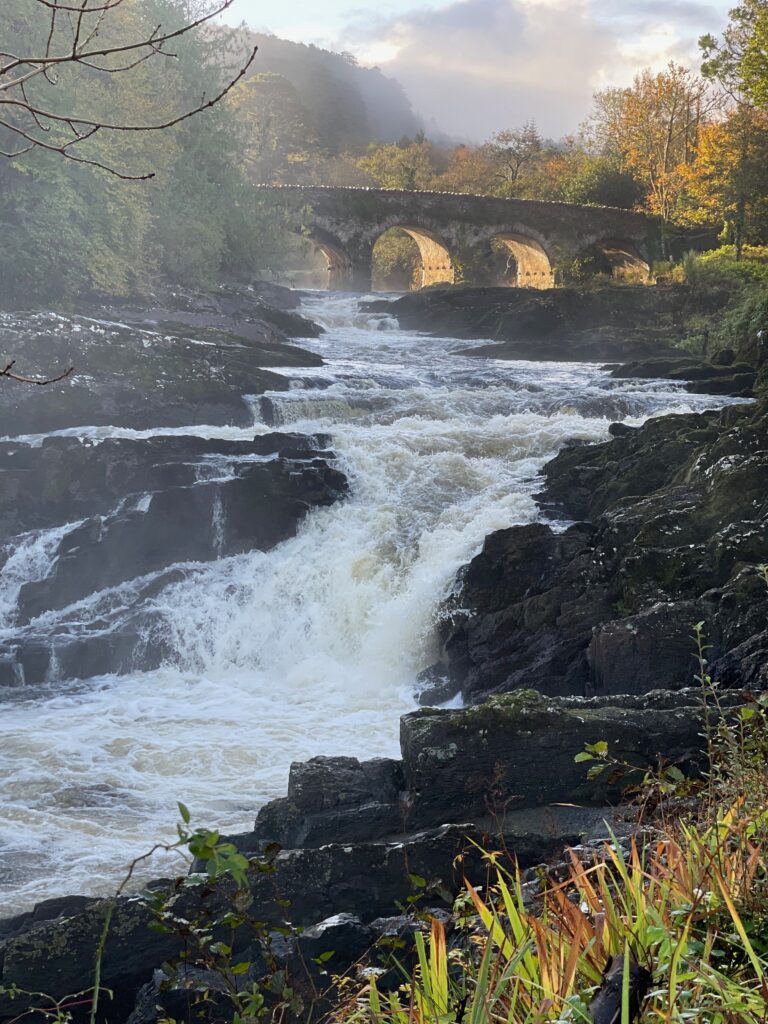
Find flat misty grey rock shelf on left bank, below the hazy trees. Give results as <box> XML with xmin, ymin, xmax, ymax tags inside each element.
<box><xmin>0</xmin><ymin>286</ymin><xmax>323</xmax><ymax>436</ymax></box>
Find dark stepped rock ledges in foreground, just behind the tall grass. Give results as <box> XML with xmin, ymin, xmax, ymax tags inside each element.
<box><xmin>0</xmin><ymin>691</ymin><xmax>743</xmax><ymax>1024</ymax></box>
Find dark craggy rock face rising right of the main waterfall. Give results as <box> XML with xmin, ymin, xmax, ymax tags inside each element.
<box><xmin>436</xmin><ymin>402</ymin><xmax>768</xmax><ymax>700</ymax></box>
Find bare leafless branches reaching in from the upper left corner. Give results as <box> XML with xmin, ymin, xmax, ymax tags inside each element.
<box><xmin>0</xmin><ymin>0</ymin><xmax>256</xmax><ymax>180</ymax></box>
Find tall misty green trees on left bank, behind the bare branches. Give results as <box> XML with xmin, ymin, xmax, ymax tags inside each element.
<box><xmin>0</xmin><ymin>0</ymin><xmax>294</xmax><ymax>306</ymax></box>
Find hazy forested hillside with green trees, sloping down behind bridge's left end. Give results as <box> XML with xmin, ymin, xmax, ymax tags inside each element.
<box><xmin>0</xmin><ymin>0</ymin><xmax>418</xmax><ymax>305</ymax></box>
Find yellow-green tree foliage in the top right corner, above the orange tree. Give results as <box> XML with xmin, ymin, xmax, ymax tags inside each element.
<box><xmin>699</xmin><ymin>0</ymin><xmax>768</xmax><ymax>110</ymax></box>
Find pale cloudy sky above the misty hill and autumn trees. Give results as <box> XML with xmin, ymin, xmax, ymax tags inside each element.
<box><xmin>221</xmin><ymin>0</ymin><xmax>733</xmax><ymax>141</ymax></box>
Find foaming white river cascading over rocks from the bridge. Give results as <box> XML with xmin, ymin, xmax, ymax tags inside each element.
<box><xmin>0</xmin><ymin>294</ymin><xmax>741</xmax><ymax>915</ymax></box>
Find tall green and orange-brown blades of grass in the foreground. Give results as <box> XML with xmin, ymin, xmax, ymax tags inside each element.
<box><xmin>335</xmin><ymin>805</ymin><xmax>768</xmax><ymax>1024</ymax></box>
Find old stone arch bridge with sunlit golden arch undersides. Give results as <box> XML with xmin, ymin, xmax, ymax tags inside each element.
<box><xmin>256</xmin><ymin>185</ymin><xmax>653</xmax><ymax>292</ymax></box>
